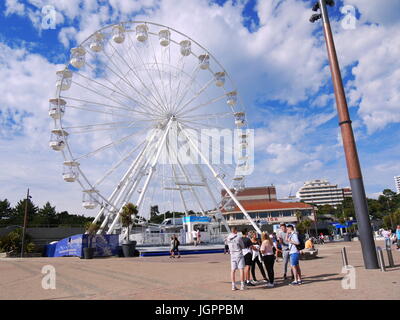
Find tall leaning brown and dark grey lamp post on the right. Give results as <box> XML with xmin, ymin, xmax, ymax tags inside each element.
<box><xmin>310</xmin><ymin>0</ymin><xmax>379</xmax><ymax>269</ymax></box>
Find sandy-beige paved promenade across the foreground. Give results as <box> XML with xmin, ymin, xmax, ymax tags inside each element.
<box><xmin>0</xmin><ymin>241</ymin><xmax>400</xmax><ymax>300</ymax></box>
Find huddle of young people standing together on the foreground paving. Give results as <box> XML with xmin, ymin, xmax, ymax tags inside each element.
<box><xmin>225</xmin><ymin>223</ymin><xmax>302</xmax><ymax>290</ymax></box>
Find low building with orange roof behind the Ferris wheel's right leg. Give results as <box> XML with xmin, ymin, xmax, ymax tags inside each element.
<box><xmin>221</xmin><ymin>186</ymin><xmax>314</xmax><ymax>226</ymax></box>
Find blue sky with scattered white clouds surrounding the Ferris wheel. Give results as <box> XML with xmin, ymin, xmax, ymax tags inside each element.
<box><xmin>0</xmin><ymin>0</ymin><xmax>400</xmax><ymax>214</ymax></box>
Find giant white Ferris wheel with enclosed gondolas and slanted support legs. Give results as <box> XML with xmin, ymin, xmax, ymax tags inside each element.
<box><xmin>49</xmin><ymin>21</ymin><xmax>259</xmax><ymax>234</ymax></box>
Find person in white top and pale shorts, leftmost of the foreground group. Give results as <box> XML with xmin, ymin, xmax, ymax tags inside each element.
<box><xmin>226</xmin><ymin>227</ymin><xmax>246</xmax><ymax>290</ymax></box>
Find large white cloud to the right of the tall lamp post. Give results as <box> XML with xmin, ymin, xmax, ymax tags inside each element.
<box><xmin>334</xmin><ymin>0</ymin><xmax>400</xmax><ymax>134</ymax></box>
